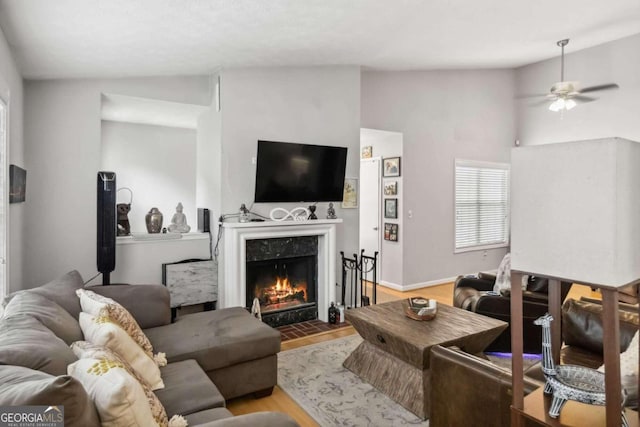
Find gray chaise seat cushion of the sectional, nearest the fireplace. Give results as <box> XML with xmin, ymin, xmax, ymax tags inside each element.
<box><xmin>145</xmin><ymin>307</ymin><xmax>280</xmax><ymax>372</ymax></box>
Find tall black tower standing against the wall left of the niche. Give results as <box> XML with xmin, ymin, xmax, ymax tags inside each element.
<box><xmin>98</xmin><ymin>172</ymin><xmax>116</xmax><ymax>285</ymax></box>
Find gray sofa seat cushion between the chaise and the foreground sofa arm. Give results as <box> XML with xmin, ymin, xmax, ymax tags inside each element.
<box><xmin>156</xmin><ymin>360</ymin><xmax>224</xmax><ymax>417</ymax></box>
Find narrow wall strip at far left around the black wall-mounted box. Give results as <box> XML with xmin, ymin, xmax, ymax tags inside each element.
<box><xmin>0</xmin><ymin>29</ymin><xmax>23</xmax><ymax>292</ymax></box>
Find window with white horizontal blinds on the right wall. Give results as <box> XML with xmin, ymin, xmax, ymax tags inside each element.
<box><xmin>455</xmin><ymin>159</ymin><xmax>509</xmax><ymax>252</ymax></box>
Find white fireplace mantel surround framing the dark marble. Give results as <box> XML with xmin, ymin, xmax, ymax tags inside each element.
<box><xmin>218</xmin><ymin>219</ymin><xmax>342</xmax><ymax>322</ymax></box>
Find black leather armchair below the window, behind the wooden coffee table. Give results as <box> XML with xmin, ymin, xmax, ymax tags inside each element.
<box><xmin>453</xmin><ymin>273</ymin><xmax>571</xmax><ymax>353</ymax></box>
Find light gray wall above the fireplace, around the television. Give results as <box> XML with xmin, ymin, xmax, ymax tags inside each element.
<box><xmin>221</xmin><ymin>67</ymin><xmax>360</xmax><ymax>277</ymax></box>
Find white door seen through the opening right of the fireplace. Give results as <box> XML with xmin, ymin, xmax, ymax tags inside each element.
<box><xmin>358</xmin><ymin>158</ymin><xmax>381</xmax><ymax>270</ymax></box>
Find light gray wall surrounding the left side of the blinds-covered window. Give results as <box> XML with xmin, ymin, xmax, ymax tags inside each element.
<box><xmin>361</xmin><ymin>70</ymin><xmax>516</xmax><ymax>289</ymax></box>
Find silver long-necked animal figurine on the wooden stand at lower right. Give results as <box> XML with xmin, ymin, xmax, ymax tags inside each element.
<box><xmin>533</xmin><ymin>313</ymin><xmax>629</xmax><ymax>427</ymax></box>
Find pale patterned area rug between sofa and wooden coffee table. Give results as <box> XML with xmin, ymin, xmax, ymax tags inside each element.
<box><xmin>278</xmin><ymin>335</ymin><xmax>429</xmax><ymax>427</ymax></box>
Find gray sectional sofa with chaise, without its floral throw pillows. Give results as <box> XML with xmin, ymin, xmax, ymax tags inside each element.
<box><xmin>0</xmin><ymin>271</ymin><xmax>298</xmax><ymax>427</ymax></box>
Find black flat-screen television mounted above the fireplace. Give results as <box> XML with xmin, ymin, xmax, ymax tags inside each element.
<box><xmin>254</xmin><ymin>141</ymin><xmax>347</xmax><ymax>203</ymax></box>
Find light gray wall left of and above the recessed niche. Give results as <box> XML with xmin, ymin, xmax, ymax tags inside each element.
<box><xmin>19</xmin><ymin>76</ymin><xmax>211</xmax><ymax>288</ymax></box>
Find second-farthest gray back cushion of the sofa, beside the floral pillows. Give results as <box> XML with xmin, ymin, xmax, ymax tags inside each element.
<box><xmin>4</xmin><ymin>292</ymin><xmax>83</xmax><ymax>344</ymax></box>
